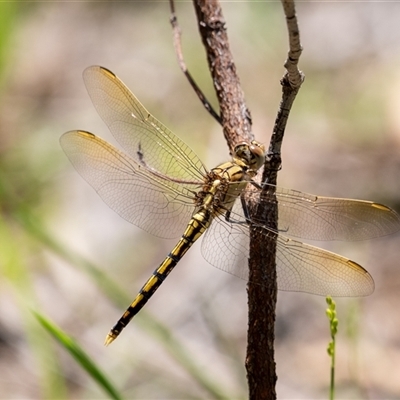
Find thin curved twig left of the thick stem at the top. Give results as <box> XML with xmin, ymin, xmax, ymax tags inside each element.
<box><xmin>169</xmin><ymin>0</ymin><xmax>222</xmax><ymax>124</ymax></box>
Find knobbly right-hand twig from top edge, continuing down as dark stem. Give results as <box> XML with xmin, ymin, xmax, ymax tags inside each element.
<box><xmin>246</xmin><ymin>0</ymin><xmax>304</xmax><ymax>400</ymax></box>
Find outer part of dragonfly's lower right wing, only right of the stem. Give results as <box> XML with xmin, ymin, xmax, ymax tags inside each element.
<box><xmin>276</xmin><ymin>236</ymin><xmax>374</xmax><ymax>296</ymax></box>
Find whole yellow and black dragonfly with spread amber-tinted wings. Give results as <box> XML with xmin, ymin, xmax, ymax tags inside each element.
<box><xmin>60</xmin><ymin>66</ymin><xmax>400</xmax><ymax>345</ymax></box>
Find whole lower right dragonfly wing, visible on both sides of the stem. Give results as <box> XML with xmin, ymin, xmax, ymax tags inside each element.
<box><xmin>202</xmin><ymin>200</ymin><xmax>374</xmax><ymax>296</ymax></box>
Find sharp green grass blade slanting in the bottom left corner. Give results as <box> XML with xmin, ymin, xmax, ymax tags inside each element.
<box><xmin>33</xmin><ymin>311</ymin><xmax>122</xmax><ymax>400</ymax></box>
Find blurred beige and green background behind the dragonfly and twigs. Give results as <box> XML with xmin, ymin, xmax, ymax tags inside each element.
<box><xmin>0</xmin><ymin>1</ymin><xmax>400</xmax><ymax>399</ymax></box>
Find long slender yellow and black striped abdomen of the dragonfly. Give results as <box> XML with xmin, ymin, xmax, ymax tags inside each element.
<box><xmin>105</xmin><ymin>210</ymin><xmax>212</xmax><ymax>346</ymax></box>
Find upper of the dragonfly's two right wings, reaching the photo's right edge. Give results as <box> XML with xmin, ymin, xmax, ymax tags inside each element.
<box><xmin>244</xmin><ymin>186</ymin><xmax>400</xmax><ymax>240</ymax></box>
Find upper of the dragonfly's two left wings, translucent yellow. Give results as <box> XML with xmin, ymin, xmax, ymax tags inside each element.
<box><xmin>83</xmin><ymin>66</ymin><xmax>207</xmax><ymax>181</ymax></box>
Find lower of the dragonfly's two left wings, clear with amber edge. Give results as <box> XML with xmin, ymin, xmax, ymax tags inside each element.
<box><xmin>60</xmin><ymin>131</ymin><xmax>202</xmax><ymax>238</ymax></box>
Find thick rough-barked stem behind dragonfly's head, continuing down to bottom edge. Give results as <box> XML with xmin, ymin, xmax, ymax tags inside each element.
<box><xmin>194</xmin><ymin>0</ymin><xmax>277</xmax><ymax>399</ymax></box>
